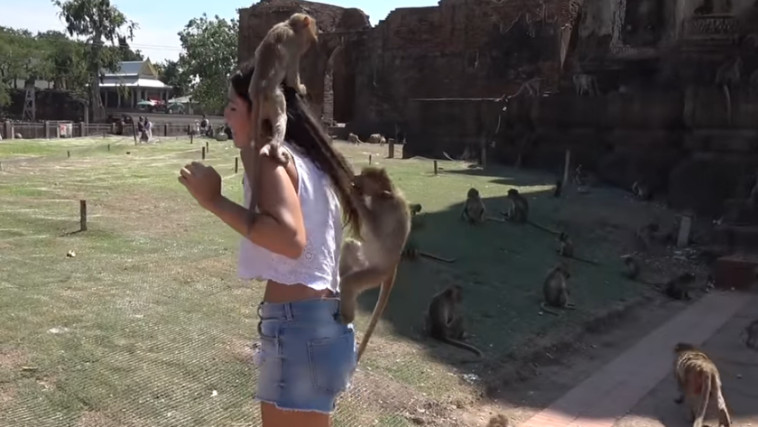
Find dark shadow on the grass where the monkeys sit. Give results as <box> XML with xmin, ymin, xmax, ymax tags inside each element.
<box><xmin>359</xmin><ymin>167</ymin><xmax>656</xmax><ymax>400</ymax></box>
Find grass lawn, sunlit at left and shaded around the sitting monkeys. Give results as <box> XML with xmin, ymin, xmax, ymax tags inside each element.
<box><xmin>0</xmin><ymin>137</ymin><xmax>664</xmax><ymax>427</ymax></box>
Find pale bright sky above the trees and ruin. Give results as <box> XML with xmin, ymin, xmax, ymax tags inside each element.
<box><xmin>0</xmin><ymin>0</ymin><xmax>437</xmax><ymax>63</ymax></box>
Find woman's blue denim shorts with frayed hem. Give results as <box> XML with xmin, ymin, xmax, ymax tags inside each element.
<box><xmin>255</xmin><ymin>298</ymin><xmax>356</xmax><ymax>414</ymax></box>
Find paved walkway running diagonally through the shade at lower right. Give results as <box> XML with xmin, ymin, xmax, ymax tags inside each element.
<box><xmin>519</xmin><ymin>292</ymin><xmax>753</xmax><ymax>427</ymax></box>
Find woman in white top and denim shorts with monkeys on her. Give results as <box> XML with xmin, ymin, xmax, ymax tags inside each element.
<box><xmin>179</xmin><ymin>58</ymin><xmax>360</xmax><ymax>427</ymax></box>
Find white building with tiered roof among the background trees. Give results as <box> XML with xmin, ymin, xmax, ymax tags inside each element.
<box><xmin>100</xmin><ymin>59</ymin><xmax>171</xmax><ymax>110</ymax></box>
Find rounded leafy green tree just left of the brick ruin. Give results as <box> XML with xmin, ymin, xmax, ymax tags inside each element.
<box><xmin>178</xmin><ymin>14</ymin><xmax>238</xmax><ymax>112</ymax></box>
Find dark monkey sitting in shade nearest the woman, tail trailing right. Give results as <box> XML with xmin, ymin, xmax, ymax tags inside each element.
<box><xmin>426</xmin><ymin>285</ymin><xmax>482</xmax><ymax>357</ymax></box>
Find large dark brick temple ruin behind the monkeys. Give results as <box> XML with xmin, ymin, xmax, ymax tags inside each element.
<box><xmin>239</xmin><ymin>0</ymin><xmax>758</xmax><ymax>226</ymax></box>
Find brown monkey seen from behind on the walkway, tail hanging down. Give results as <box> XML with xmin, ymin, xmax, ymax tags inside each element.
<box><xmin>674</xmin><ymin>343</ymin><xmax>732</xmax><ymax>427</ymax></box>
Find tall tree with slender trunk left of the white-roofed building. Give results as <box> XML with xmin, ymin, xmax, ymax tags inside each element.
<box><xmin>52</xmin><ymin>0</ymin><xmax>137</xmax><ymax>121</ymax></box>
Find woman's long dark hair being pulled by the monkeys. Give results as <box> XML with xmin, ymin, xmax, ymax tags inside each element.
<box><xmin>230</xmin><ymin>60</ymin><xmax>360</xmax><ymax>233</ymax></box>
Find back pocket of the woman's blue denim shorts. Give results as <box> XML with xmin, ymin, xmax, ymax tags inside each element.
<box><xmin>308</xmin><ymin>331</ymin><xmax>355</xmax><ymax>393</ymax></box>
